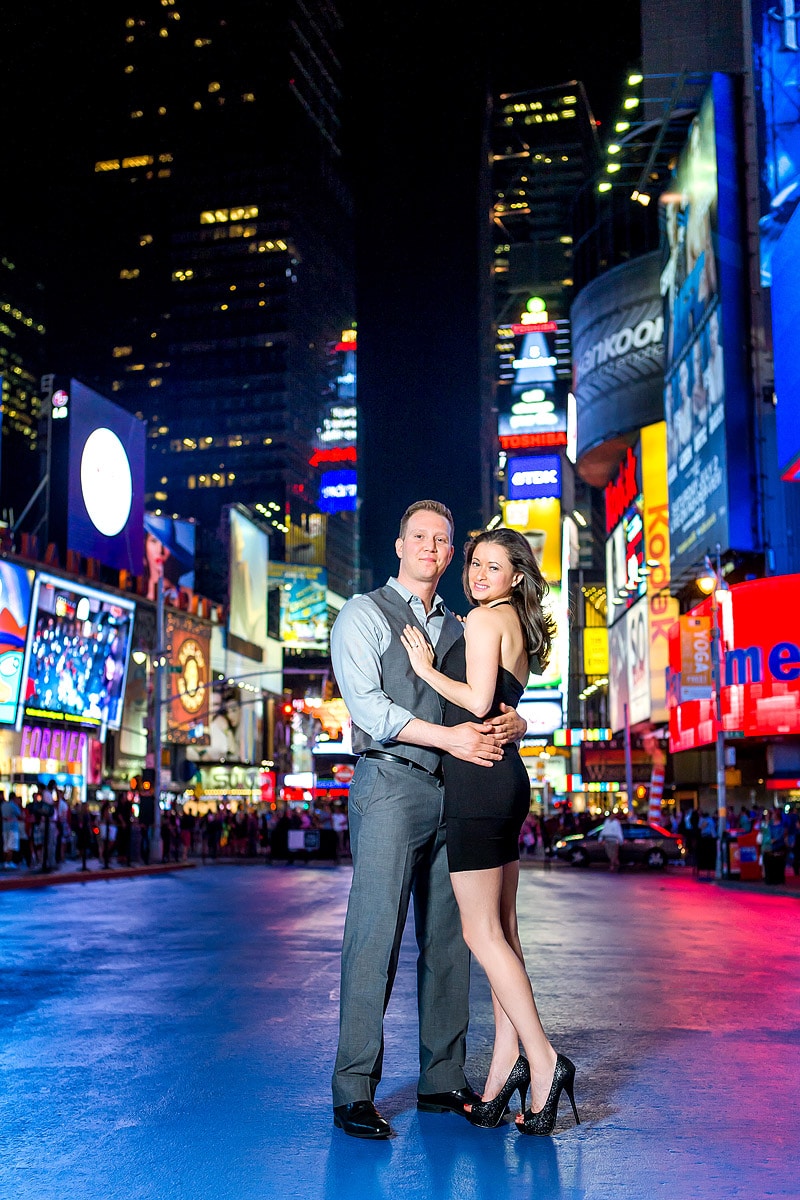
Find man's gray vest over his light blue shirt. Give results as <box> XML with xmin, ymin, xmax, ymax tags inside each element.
<box><xmin>353</xmin><ymin>584</ymin><xmax>464</xmax><ymax>772</ymax></box>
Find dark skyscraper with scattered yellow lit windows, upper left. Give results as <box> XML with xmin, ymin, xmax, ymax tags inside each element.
<box><xmin>86</xmin><ymin>0</ymin><xmax>355</xmax><ymax>597</ymax></box>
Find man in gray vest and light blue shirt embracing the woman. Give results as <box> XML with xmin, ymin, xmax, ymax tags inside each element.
<box><xmin>331</xmin><ymin>500</ymin><xmax>525</xmax><ymax>1139</ymax></box>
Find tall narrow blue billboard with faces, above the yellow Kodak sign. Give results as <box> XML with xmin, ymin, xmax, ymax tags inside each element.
<box><xmin>661</xmin><ymin>91</ymin><xmax>729</xmax><ymax>577</ymax></box>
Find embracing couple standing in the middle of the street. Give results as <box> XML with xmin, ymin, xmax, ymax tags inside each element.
<box><xmin>331</xmin><ymin>500</ymin><xmax>578</xmax><ymax>1139</ymax></box>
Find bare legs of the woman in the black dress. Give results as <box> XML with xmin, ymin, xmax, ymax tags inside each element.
<box><xmin>451</xmin><ymin>864</ymin><xmax>555</xmax><ymax>1112</ymax></box>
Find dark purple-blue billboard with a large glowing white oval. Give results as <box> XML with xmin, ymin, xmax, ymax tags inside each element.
<box><xmin>50</xmin><ymin>379</ymin><xmax>145</xmax><ymax>575</ymax></box>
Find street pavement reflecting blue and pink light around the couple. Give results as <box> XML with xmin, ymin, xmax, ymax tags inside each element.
<box><xmin>0</xmin><ymin>864</ymin><xmax>800</xmax><ymax>1200</ymax></box>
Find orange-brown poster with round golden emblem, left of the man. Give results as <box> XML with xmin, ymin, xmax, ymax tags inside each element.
<box><xmin>164</xmin><ymin>612</ymin><xmax>211</xmax><ymax>745</ymax></box>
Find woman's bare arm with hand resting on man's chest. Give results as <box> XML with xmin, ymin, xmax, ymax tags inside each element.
<box><xmin>401</xmin><ymin>608</ymin><xmax>503</xmax><ymax>718</ymax></box>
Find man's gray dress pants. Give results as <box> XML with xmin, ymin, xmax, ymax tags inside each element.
<box><xmin>332</xmin><ymin>758</ymin><xmax>469</xmax><ymax>1105</ymax></box>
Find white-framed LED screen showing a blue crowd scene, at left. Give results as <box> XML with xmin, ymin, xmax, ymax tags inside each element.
<box><xmin>20</xmin><ymin>575</ymin><xmax>136</xmax><ymax>730</ymax></box>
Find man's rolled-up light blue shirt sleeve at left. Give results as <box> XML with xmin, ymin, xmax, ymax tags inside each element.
<box><xmin>331</xmin><ymin>596</ymin><xmax>414</xmax><ymax>742</ymax></box>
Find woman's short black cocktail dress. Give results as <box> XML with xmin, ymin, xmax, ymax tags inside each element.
<box><xmin>441</xmin><ymin>637</ymin><xmax>530</xmax><ymax>871</ymax></box>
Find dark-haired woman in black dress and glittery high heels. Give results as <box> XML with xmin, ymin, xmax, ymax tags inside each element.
<box><xmin>403</xmin><ymin>529</ymin><xmax>578</xmax><ymax>1134</ymax></box>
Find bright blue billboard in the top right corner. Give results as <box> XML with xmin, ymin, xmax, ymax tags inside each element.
<box><xmin>752</xmin><ymin>0</ymin><xmax>800</xmax><ymax>287</ymax></box>
